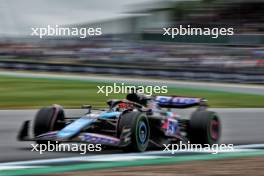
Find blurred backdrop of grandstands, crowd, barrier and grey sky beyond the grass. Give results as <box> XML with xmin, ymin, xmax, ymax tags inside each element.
<box><xmin>0</xmin><ymin>0</ymin><xmax>264</xmax><ymax>83</ymax></box>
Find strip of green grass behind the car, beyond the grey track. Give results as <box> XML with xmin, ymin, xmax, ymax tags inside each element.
<box><xmin>0</xmin><ymin>76</ymin><xmax>264</xmax><ymax>109</ymax></box>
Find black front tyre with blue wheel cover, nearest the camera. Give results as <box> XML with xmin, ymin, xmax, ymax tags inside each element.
<box><xmin>118</xmin><ymin>112</ymin><xmax>150</xmax><ymax>152</ymax></box>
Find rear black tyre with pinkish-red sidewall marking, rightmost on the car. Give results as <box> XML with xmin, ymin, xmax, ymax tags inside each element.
<box><xmin>188</xmin><ymin>111</ymin><xmax>221</xmax><ymax>145</ymax></box>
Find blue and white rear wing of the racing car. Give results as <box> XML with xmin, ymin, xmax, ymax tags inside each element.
<box><xmin>155</xmin><ymin>96</ymin><xmax>207</xmax><ymax>108</ymax></box>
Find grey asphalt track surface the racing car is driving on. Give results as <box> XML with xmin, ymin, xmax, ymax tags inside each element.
<box><xmin>0</xmin><ymin>108</ymin><xmax>264</xmax><ymax>163</ymax></box>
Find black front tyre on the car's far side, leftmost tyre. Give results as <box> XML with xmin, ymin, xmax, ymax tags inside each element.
<box><xmin>33</xmin><ymin>106</ymin><xmax>65</xmax><ymax>143</ymax></box>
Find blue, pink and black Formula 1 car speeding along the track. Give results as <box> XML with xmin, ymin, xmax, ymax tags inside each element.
<box><xmin>18</xmin><ymin>93</ymin><xmax>221</xmax><ymax>152</ymax></box>
